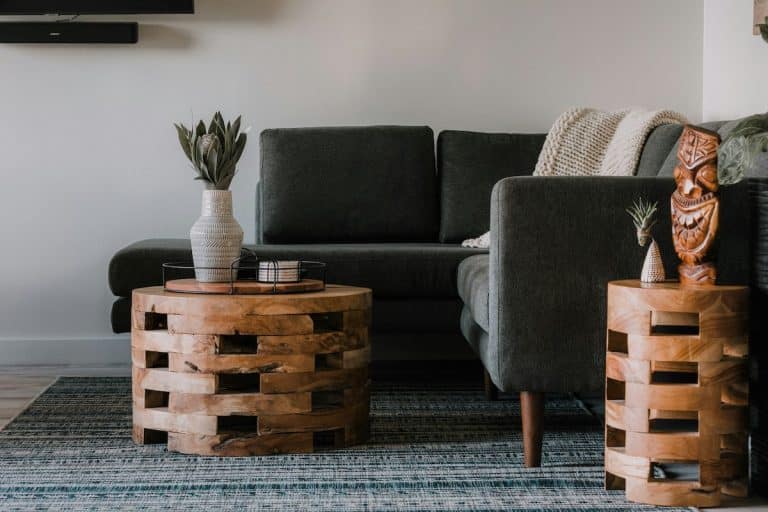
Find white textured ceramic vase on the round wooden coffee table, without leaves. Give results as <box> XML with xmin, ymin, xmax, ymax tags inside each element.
<box><xmin>189</xmin><ymin>190</ymin><xmax>243</xmax><ymax>283</ymax></box>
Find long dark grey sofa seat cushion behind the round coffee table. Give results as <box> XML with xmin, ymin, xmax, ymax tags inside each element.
<box><xmin>109</xmin><ymin>239</ymin><xmax>487</xmax><ymax>298</ymax></box>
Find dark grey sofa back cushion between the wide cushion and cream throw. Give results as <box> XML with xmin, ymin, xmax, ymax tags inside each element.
<box><xmin>437</xmin><ymin>131</ymin><xmax>546</xmax><ymax>243</ymax></box>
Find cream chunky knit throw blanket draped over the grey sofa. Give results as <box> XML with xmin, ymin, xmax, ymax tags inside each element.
<box><xmin>461</xmin><ymin>108</ymin><xmax>688</xmax><ymax>247</ymax></box>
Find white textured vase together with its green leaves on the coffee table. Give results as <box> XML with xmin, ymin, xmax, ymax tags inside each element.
<box><xmin>174</xmin><ymin>112</ymin><xmax>248</xmax><ymax>283</ymax></box>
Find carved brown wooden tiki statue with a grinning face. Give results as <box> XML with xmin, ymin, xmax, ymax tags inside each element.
<box><xmin>672</xmin><ymin>126</ymin><xmax>720</xmax><ymax>285</ymax></box>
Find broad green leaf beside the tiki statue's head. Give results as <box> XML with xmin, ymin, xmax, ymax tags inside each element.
<box><xmin>717</xmin><ymin>114</ymin><xmax>768</xmax><ymax>185</ymax></box>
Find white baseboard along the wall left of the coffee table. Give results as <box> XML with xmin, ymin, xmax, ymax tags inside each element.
<box><xmin>0</xmin><ymin>335</ymin><xmax>131</xmax><ymax>367</ymax></box>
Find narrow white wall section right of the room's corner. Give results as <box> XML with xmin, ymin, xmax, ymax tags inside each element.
<box><xmin>702</xmin><ymin>0</ymin><xmax>768</xmax><ymax>120</ymax></box>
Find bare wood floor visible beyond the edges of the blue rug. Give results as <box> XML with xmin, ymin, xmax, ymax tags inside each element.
<box><xmin>0</xmin><ymin>366</ymin><xmax>768</xmax><ymax>512</ymax></box>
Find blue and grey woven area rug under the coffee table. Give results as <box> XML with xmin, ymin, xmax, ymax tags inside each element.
<box><xmin>0</xmin><ymin>378</ymin><xmax>689</xmax><ymax>511</ymax></box>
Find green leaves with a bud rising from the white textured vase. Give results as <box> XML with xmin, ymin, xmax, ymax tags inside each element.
<box><xmin>174</xmin><ymin>112</ymin><xmax>248</xmax><ymax>190</ymax></box>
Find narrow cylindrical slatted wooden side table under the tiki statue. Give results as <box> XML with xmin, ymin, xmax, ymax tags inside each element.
<box><xmin>605</xmin><ymin>281</ymin><xmax>749</xmax><ymax>507</ymax></box>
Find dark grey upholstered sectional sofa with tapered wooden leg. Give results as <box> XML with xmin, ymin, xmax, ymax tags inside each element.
<box><xmin>109</xmin><ymin>125</ymin><xmax>768</xmax><ymax>474</ymax></box>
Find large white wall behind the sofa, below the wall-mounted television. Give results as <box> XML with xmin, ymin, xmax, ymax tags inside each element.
<box><xmin>0</xmin><ymin>0</ymin><xmax>704</xmax><ymax>364</ymax></box>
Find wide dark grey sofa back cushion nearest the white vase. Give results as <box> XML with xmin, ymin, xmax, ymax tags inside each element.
<box><xmin>257</xmin><ymin>126</ymin><xmax>439</xmax><ymax>243</ymax></box>
